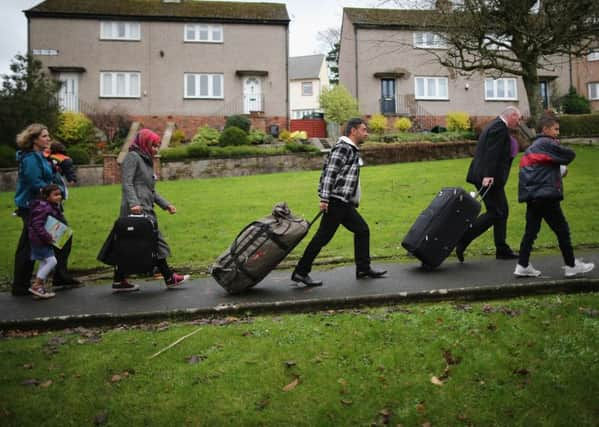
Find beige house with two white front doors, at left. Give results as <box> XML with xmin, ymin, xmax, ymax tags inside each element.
<box><xmin>25</xmin><ymin>0</ymin><xmax>289</xmax><ymax>133</ymax></box>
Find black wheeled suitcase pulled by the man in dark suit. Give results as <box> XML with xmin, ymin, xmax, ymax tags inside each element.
<box><xmin>401</xmin><ymin>187</ymin><xmax>481</xmax><ymax>267</ymax></box>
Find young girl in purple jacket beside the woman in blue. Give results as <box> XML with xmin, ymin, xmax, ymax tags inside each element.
<box><xmin>28</xmin><ymin>184</ymin><xmax>66</xmax><ymax>299</ymax></box>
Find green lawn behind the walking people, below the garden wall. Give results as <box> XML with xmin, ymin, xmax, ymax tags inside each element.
<box><xmin>0</xmin><ymin>146</ymin><xmax>599</xmax><ymax>283</ymax></box>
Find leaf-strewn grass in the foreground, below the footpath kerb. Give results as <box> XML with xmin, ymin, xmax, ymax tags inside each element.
<box><xmin>0</xmin><ymin>294</ymin><xmax>599</xmax><ymax>427</ymax></box>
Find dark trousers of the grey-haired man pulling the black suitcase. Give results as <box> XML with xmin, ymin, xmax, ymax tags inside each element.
<box><xmin>460</xmin><ymin>185</ymin><xmax>509</xmax><ymax>252</ymax></box>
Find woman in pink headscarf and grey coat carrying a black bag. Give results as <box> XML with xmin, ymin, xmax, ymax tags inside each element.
<box><xmin>112</xmin><ymin>129</ymin><xmax>189</xmax><ymax>292</ymax></box>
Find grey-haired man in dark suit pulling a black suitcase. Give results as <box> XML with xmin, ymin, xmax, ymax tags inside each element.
<box><xmin>456</xmin><ymin>107</ymin><xmax>522</xmax><ymax>262</ymax></box>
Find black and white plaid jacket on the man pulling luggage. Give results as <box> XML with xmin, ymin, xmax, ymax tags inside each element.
<box><xmin>318</xmin><ymin>136</ymin><xmax>360</xmax><ymax>203</ymax></box>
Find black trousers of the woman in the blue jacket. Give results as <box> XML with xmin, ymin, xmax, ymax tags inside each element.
<box><xmin>12</xmin><ymin>208</ymin><xmax>73</xmax><ymax>294</ymax></box>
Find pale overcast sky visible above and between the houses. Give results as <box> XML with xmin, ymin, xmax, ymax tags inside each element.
<box><xmin>0</xmin><ymin>0</ymin><xmax>381</xmax><ymax>74</ymax></box>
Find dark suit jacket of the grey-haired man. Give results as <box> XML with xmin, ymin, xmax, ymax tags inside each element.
<box><xmin>466</xmin><ymin>117</ymin><xmax>512</xmax><ymax>187</ymax></box>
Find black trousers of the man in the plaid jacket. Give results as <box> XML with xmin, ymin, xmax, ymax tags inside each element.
<box><xmin>295</xmin><ymin>197</ymin><xmax>370</xmax><ymax>275</ymax></box>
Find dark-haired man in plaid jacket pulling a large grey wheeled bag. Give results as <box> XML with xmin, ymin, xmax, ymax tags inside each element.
<box><xmin>291</xmin><ymin>118</ymin><xmax>387</xmax><ymax>286</ymax></box>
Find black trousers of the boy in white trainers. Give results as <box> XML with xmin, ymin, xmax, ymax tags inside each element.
<box><xmin>518</xmin><ymin>199</ymin><xmax>574</xmax><ymax>267</ymax></box>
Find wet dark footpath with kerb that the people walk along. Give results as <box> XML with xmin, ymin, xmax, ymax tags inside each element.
<box><xmin>0</xmin><ymin>250</ymin><xmax>599</xmax><ymax>329</ymax></box>
